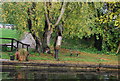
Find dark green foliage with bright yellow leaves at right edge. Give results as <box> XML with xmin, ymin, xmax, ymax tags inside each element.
<box><xmin>97</xmin><ymin>2</ymin><xmax>120</xmax><ymax>52</ymax></box>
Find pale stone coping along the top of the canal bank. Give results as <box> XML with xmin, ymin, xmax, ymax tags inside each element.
<box><xmin>0</xmin><ymin>60</ymin><xmax>120</xmax><ymax>69</ymax></box>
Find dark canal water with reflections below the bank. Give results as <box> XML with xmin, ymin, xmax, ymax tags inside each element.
<box><xmin>1</xmin><ymin>67</ymin><xmax>119</xmax><ymax>81</ymax></box>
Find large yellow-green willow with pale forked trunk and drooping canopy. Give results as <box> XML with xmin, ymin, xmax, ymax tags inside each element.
<box><xmin>3</xmin><ymin>2</ymin><xmax>101</xmax><ymax>52</ymax></box>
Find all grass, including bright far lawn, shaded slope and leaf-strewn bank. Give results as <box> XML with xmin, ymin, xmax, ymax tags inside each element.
<box><xmin>0</xmin><ymin>29</ymin><xmax>118</xmax><ymax>64</ymax></box>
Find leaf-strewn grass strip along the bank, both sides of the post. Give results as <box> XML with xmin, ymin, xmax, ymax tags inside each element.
<box><xmin>2</xmin><ymin>49</ymin><xmax>118</xmax><ymax>65</ymax></box>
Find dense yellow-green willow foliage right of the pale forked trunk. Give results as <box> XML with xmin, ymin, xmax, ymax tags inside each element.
<box><xmin>63</xmin><ymin>2</ymin><xmax>101</xmax><ymax>39</ymax></box>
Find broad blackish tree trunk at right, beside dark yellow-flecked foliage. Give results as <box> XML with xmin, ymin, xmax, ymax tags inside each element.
<box><xmin>94</xmin><ymin>34</ymin><xmax>102</xmax><ymax>51</ymax></box>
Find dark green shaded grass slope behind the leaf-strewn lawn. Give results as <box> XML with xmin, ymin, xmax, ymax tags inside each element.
<box><xmin>61</xmin><ymin>39</ymin><xmax>116</xmax><ymax>55</ymax></box>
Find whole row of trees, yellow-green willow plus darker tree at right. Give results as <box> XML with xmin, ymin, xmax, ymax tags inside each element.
<box><xmin>2</xmin><ymin>2</ymin><xmax>120</xmax><ymax>52</ymax></box>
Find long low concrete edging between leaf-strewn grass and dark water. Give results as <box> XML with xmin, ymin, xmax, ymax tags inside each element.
<box><xmin>0</xmin><ymin>61</ymin><xmax>120</xmax><ymax>70</ymax></box>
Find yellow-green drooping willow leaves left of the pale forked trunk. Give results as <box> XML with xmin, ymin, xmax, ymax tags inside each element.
<box><xmin>2</xmin><ymin>2</ymin><xmax>45</xmax><ymax>36</ymax></box>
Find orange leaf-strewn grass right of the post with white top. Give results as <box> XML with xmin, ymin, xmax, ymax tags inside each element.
<box><xmin>59</xmin><ymin>49</ymin><xmax>118</xmax><ymax>63</ymax></box>
